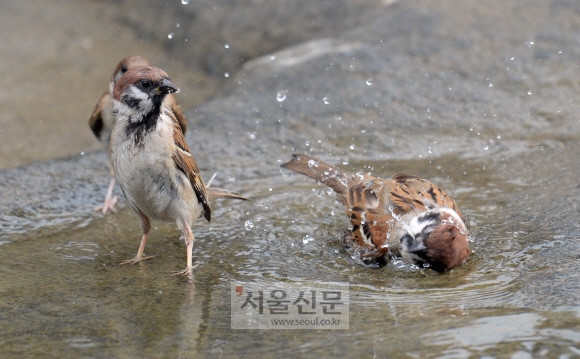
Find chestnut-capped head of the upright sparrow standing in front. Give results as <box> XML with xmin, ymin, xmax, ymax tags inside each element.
<box><xmin>113</xmin><ymin>66</ymin><xmax>178</xmax><ymax>116</ymax></box>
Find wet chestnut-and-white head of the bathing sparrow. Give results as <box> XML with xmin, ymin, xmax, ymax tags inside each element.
<box><xmin>401</xmin><ymin>207</ymin><xmax>469</xmax><ymax>272</ymax></box>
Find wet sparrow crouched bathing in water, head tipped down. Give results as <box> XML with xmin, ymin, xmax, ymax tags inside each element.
<box><xmin>282</xmin><ymin>155</ymin><xmax>470</xmax><ymax>272</ymax></box>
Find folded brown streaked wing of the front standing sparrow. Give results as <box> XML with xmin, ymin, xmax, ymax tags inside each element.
<box><xmin>166</xmin><ymin>108</ymin><xmax>211</xmax><ymax>222</ymax></box>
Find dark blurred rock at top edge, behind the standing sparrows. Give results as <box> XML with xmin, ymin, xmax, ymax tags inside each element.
<box><xmin>114</xmin><ymin>0</ymin><xmax>393</xmax><ymax>78</ymax></box>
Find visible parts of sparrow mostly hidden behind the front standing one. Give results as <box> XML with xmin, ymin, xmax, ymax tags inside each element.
<box><xmin>89</xmin><ymin>56</ymin><xmax>187</xmax><ymax>214</ymax></box>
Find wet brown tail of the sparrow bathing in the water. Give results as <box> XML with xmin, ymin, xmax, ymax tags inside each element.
<box><xmin>280</xmin><ymin>154</ymin><xmax>352</xmax><ymax>196</ymax></box>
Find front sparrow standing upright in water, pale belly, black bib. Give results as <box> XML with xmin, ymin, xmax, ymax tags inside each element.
<box><xmin>110</xmin><ymin>66</ymin><xmax>246</xmax><ymax>275</ymax></box>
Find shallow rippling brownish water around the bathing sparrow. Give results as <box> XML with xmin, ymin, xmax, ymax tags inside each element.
<box><xmin>0</xmin><ymin>142</ymin><xmax>580</xmax><ymax>358</ymax></box>
